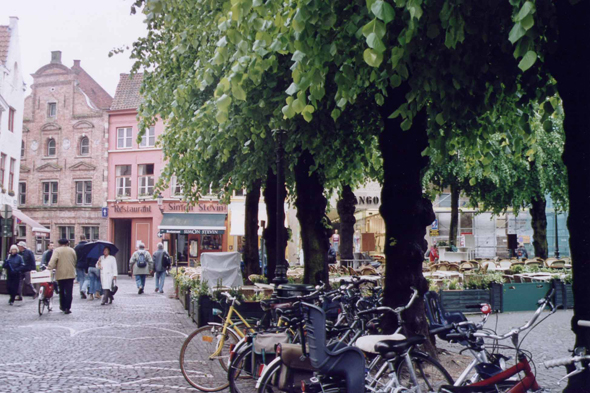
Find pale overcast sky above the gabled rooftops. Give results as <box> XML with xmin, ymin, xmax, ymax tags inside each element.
<box><xmin>0</xmin><ymin>0</ymin><xmax>147</xmax><ymax>96</ymax></box>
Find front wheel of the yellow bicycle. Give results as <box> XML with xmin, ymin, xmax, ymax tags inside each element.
<box><xmin>180</xmin><ymin>325</ymin><xmax>238</xmax><ymax>392</ymax></box>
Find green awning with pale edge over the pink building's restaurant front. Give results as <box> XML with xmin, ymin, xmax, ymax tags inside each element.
<box><xmin>158</xmin><ymin>213</ymin><xmax>226</xmax><ymax>235</ymax></box>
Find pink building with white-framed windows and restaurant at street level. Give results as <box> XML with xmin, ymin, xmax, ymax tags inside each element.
<box><xmin>107</xmin><ymin>74</ymin><xmax>227</xmax><ymax>271</ymax></box>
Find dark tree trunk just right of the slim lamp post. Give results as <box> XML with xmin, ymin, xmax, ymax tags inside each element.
<box><xmin>295</xmin><ymin>150</ymin><xmax>330</xmax><ymax>284</ymax></box>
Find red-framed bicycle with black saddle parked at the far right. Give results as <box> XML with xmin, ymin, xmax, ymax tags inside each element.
<box><xmin>438</xmin><ymin>290</ymin><xmax>557</xmax><ymax>393</ymax></box>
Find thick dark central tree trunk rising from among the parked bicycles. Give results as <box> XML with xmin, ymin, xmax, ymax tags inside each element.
<box><xmin>379</xmin><ymin>86</ymin><xmax>435</xmax><ymax>352</ymax></box>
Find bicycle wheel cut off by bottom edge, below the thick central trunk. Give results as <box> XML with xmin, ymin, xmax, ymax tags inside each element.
<box><xmin>397</xmin><ymin>352</ymin><xmax>453</xmax><ymax>392</ymax></box>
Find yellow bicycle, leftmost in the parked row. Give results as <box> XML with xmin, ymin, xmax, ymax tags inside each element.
<box><xmin>180</xmin><ymin>292</ymin><xmax>255</xmax><ymax>392</ymax></box>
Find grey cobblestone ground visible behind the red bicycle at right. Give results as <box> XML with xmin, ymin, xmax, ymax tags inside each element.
<box><xmin>437</xmin><ymin>310</ymin><xmax>574</xmax><ymax>392</ymax></box>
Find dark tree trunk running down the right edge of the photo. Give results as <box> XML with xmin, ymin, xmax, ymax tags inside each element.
<box><xmin>548</xmin><ymin>0</ymin><xmax>590</xmax><ymax>392</ymax></box>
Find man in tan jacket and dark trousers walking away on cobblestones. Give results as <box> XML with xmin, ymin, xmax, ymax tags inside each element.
<box><xmin>47</xmin><ymin>239</ymin><xmax>76</xmax><ymax>314</ymax></box>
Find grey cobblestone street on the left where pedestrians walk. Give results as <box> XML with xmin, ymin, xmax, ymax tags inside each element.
<box><xmin>0</xmin><ymin>277</ymin><xmax>196</xmax><ymax>393</ymax></box>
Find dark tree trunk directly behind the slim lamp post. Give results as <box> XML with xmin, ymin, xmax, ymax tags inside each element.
<box><xmin>263</xmin><ymin>168</ymin><xmax>288</xmax><ymax>282</ymax></box>
